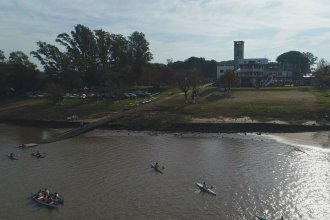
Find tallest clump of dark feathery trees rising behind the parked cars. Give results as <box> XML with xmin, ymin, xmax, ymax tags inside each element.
<box><xmin>31</xmin><ymin>24</ymin><xmax>152</xmax><ymax>88</ymax></box>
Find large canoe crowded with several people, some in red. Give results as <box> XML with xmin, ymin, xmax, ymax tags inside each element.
<box><xmin>31</xmin><ymin>188</ymin><xmax>64</xmax><ymax>208</ymax></box>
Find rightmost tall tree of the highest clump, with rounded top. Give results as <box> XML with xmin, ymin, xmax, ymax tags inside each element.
<box><xmin>128</xmin><ymin>31</ymin><xmax>152</xmax><ymax>80</ymax></box>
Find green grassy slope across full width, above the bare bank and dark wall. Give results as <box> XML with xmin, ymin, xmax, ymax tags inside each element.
<box><xmin>0</xmin><ymin>87</ymin><xmax>330</xmax><ymax>122</ymax></box>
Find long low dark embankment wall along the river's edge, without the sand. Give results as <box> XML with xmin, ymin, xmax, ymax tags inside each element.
<box><xmin>0</xmin><ymin>118</ymin><xmax>330</xmax><ymax>133</ymax></box>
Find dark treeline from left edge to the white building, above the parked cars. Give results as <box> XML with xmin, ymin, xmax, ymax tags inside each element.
<box><xmin>0</xmin><ymin>24</ymin><xmax>217</xmax><ymax>95</ymax></box>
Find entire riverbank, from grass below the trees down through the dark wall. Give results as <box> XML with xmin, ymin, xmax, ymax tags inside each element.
<box><xmin>0</xmin><ymin>87</ymin><xmax>330</xmax><ymax>133</ymax></box>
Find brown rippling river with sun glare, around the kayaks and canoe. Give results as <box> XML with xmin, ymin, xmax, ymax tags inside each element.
<box><xmin>0</xmin><ymin>124</ymin><xmax>330</xmax><ymax>220</ymax></box>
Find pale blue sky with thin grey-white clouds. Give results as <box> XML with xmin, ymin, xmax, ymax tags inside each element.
<box><xmin>0</xmin><ymin>0</ymin><xmax>330</xmax><ymax>67</ymax></box>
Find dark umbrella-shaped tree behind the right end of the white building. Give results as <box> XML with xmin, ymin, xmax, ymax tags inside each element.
<box><xmin>276</xmin><ymin>51</ymin><xmax>312</xmax><ymax>73</ymax></box>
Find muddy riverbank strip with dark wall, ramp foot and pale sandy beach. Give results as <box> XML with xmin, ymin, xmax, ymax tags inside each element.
<box><xmin>0</xmin><ymin>112</ymin><xmax>330</xmax><ymax>151</ymax></box>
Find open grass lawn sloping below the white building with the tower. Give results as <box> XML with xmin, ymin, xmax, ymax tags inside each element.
<box><xmin>153</xmin><ymin>87</ymin><xmax>330</xmax><ymax>122</ymax></box>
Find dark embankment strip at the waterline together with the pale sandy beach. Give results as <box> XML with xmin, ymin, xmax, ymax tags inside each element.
<box><xmin>0</xmin><ymin>118</ymin><xmax>330</xmax><ymax>152</ymax></box>
